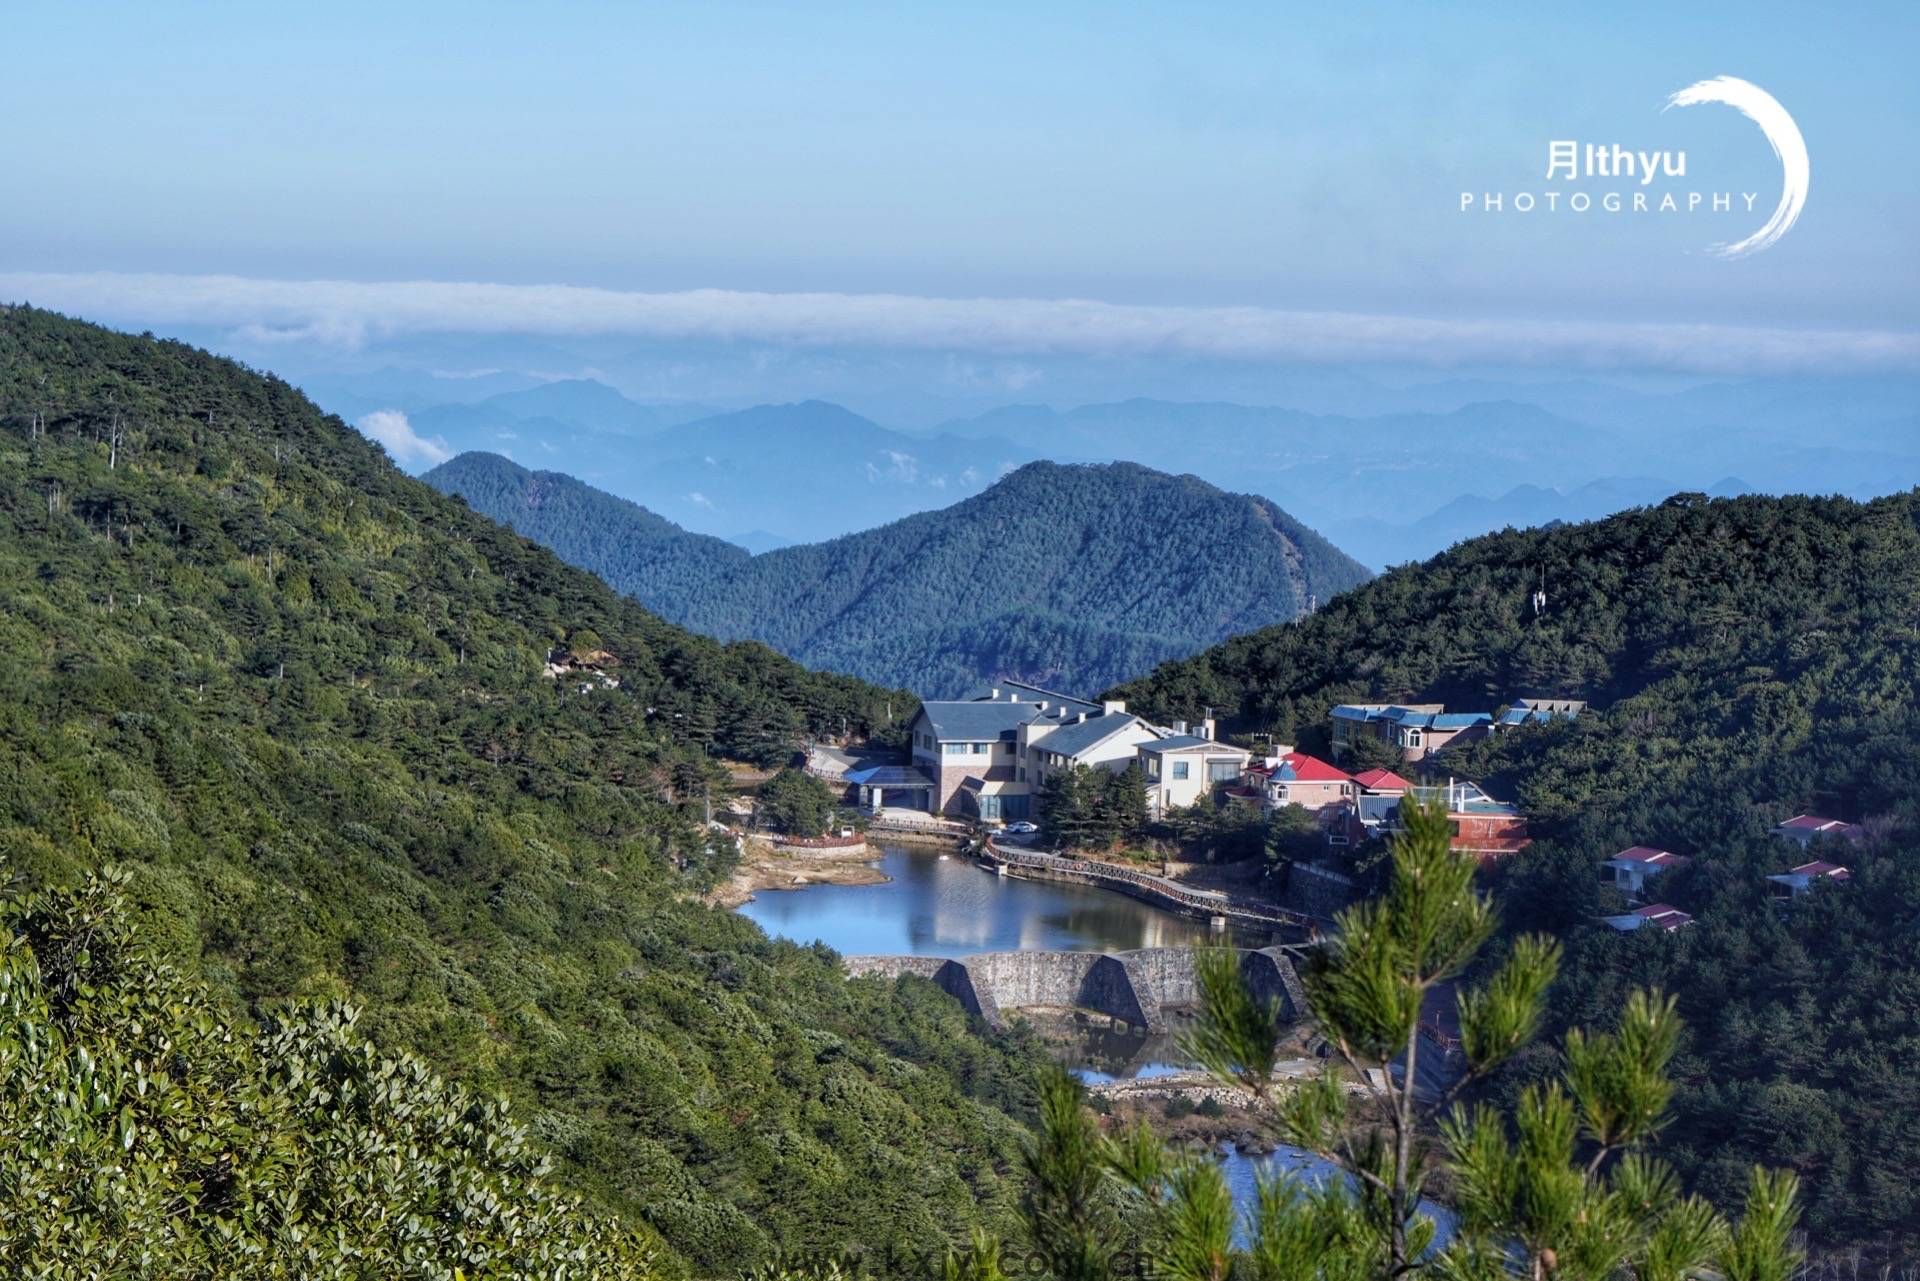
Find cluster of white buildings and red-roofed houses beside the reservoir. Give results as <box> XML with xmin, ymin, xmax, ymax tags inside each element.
<box><xmin>806</xmin><ymin>680</ymin><xmax>1862</xmax><ymax>933</ymax></box>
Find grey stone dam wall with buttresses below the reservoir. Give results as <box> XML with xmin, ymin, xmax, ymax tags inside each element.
<box><xmin>843</xmin><ymin>947</ymin><xmax>1308</xmax><ymax>1031</ymax></box>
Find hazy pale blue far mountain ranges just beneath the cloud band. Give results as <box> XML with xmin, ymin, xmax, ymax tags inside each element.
<box><xmin>366</xmin><ymin>376</ymin><xmax>1920</xmax><ymax>568</ymax></box>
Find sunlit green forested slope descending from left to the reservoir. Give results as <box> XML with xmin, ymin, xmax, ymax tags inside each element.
<box><xmin>0</xmin><ymin>307</ymin><xmax>1029</xmax><ymax>1273</ymax></box>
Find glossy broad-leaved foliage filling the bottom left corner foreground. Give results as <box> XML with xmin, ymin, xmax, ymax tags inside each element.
<box><xmin>0</xmin><ymin>874</ymin><xmax>660</xmax><ymax>1281</ymax></box>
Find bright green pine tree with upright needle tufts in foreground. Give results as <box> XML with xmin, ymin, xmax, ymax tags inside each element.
<box><xmin>952</xmin><ymin>803</ymin><xmax>1799</xmax><ymax>1281</ymax></box>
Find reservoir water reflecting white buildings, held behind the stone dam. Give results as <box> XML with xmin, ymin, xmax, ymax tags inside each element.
<box><xmin>739</xmin><ymin>845</ymin><xmax>1269</xmax><ymax>956</ymax></box>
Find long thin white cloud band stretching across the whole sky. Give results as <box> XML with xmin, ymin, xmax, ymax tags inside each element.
<box><xmin>0</xmin><ymin>273</ymin><xmax>1920</xmax><ymax>375</ymax></box>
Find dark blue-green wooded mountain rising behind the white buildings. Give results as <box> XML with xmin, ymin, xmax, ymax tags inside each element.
<box><xmin>424</xmin><ymin>451</ymin><xmax>1369</xmax><ymax>695</ymax></box>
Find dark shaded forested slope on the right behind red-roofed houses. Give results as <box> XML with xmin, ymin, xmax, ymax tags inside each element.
<box><xmin>1119</xmin><ymin>492</ymin><xmax>1920</xmax><ymax>1252</ymax></box>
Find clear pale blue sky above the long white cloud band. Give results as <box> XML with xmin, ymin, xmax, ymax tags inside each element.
<box><xmin>0</xmin><ymin>4</ymin><xmax>1920</xmax><ymax>367</ymax></box>
